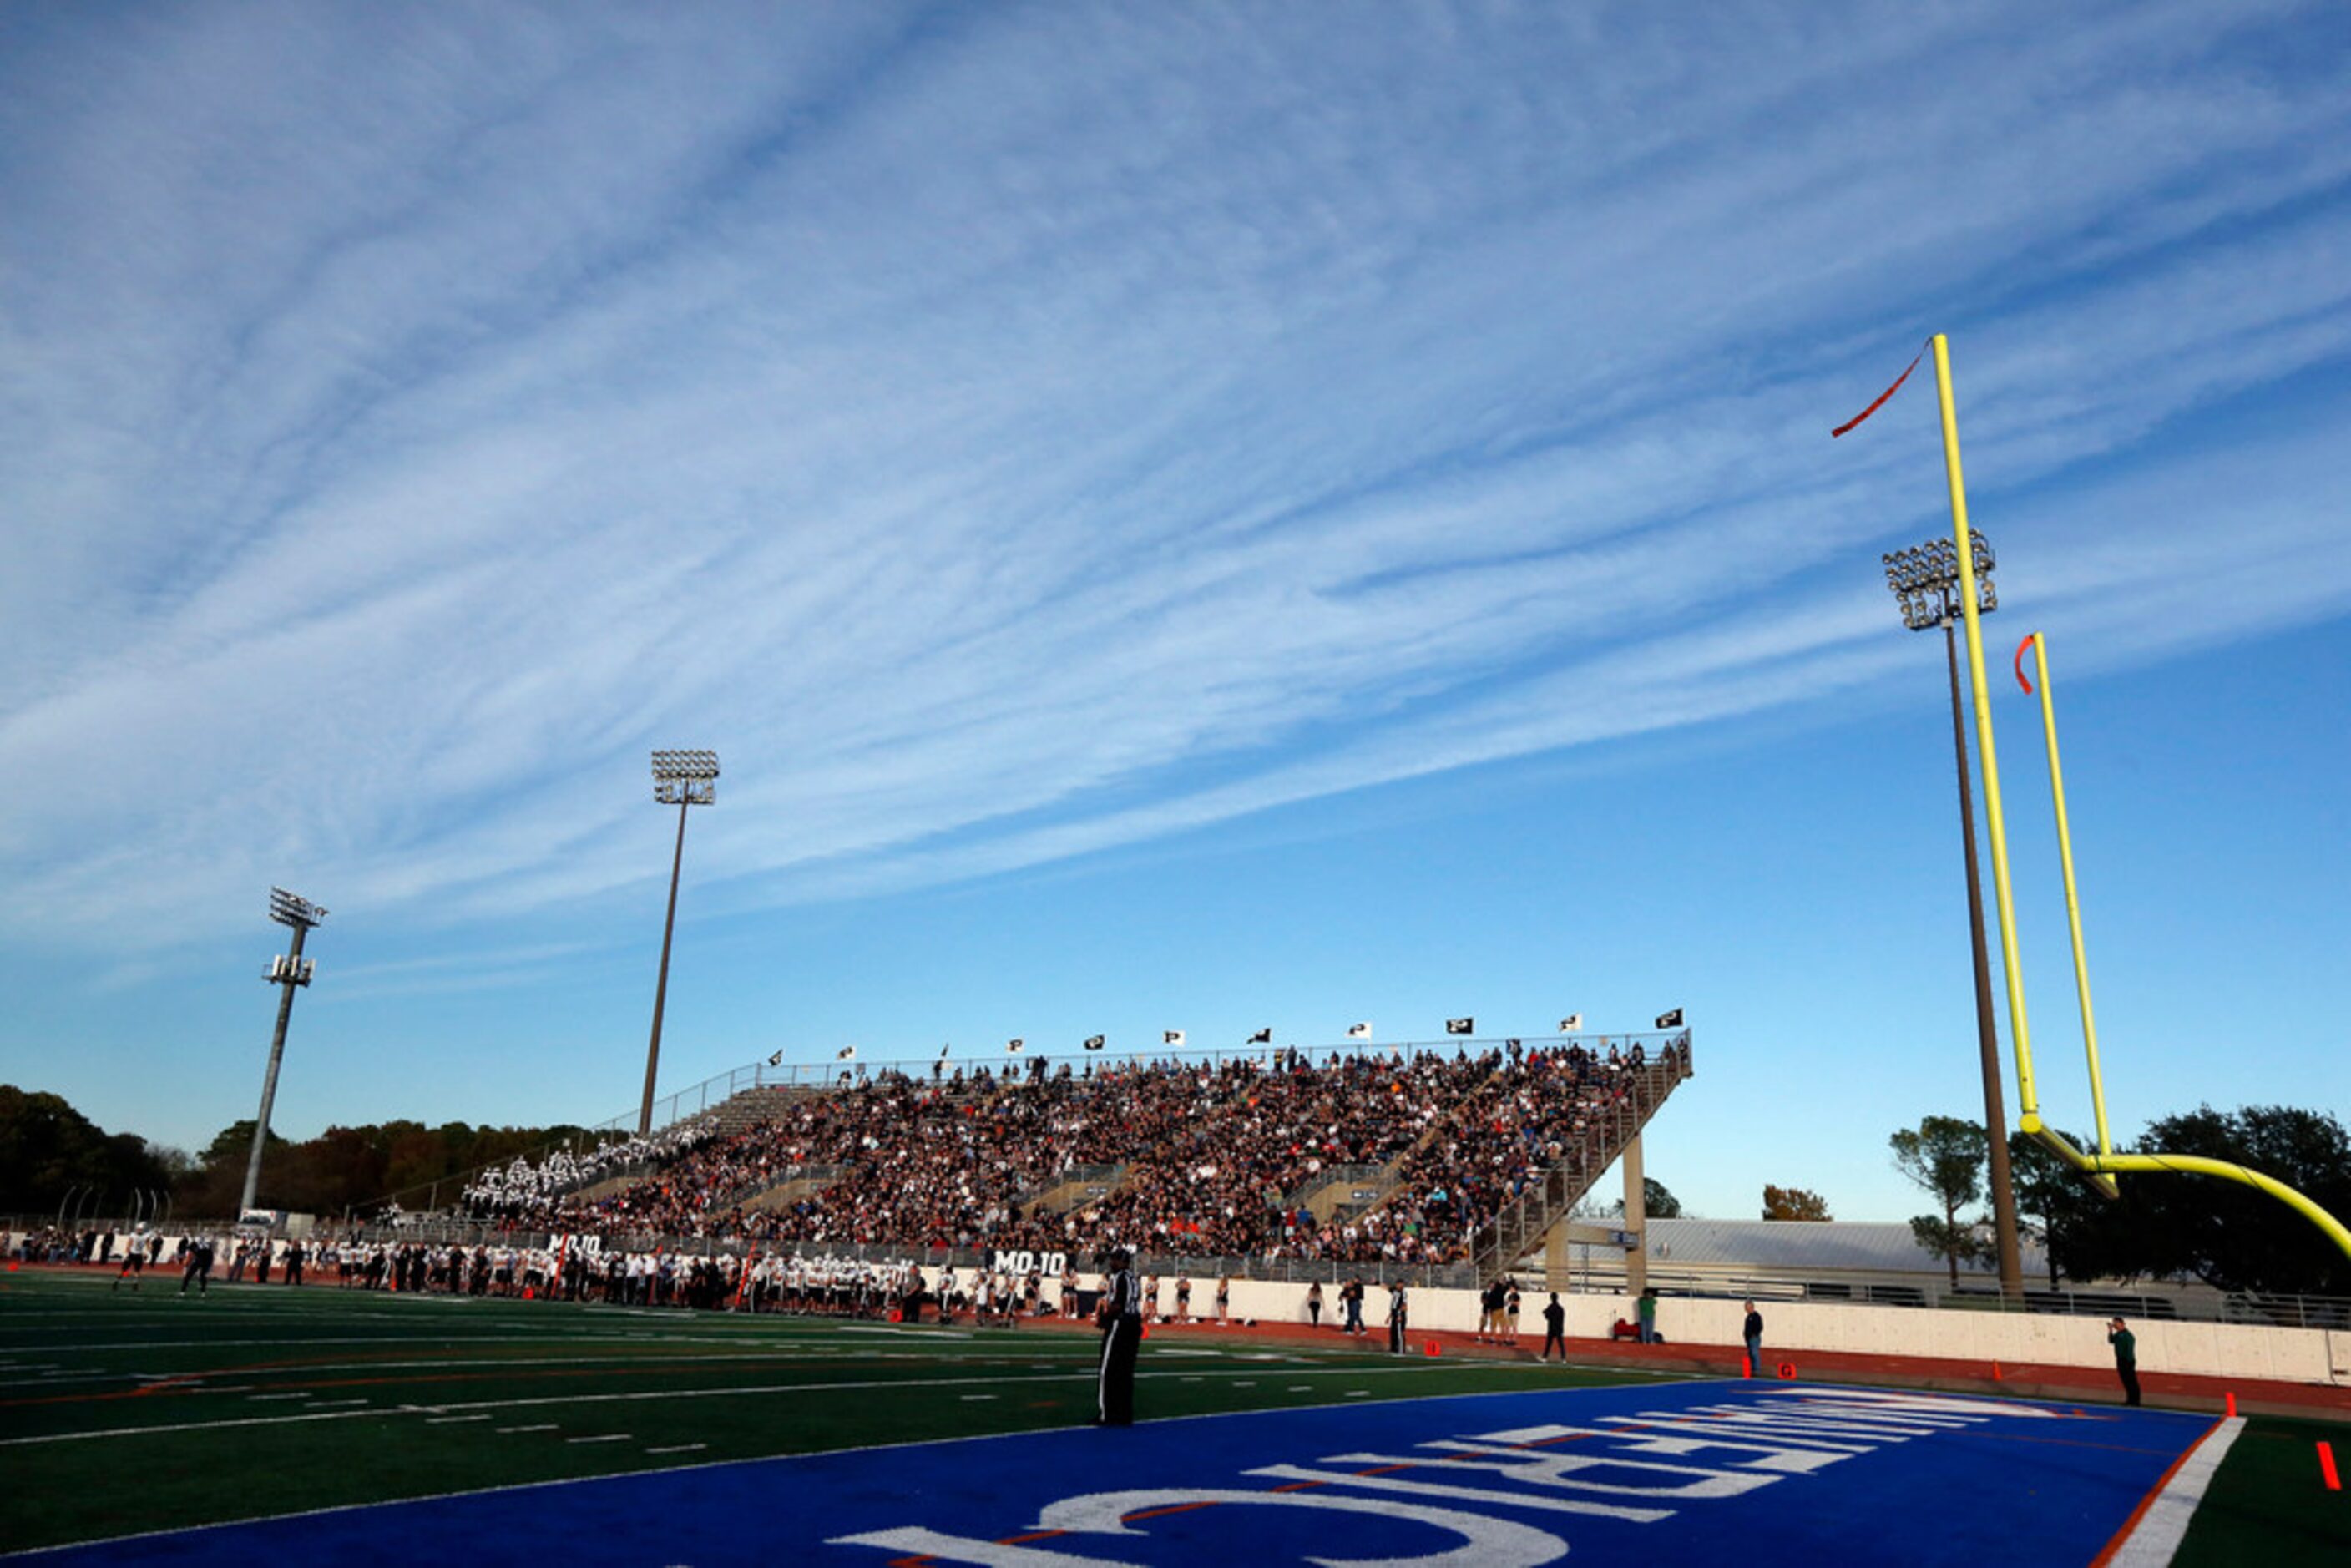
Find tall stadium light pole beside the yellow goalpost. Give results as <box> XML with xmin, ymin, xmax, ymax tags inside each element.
<box><xmin>1881</xmin><ymin>529</ymin><xmax>2025</xmax><ymax>1302</ymax></box>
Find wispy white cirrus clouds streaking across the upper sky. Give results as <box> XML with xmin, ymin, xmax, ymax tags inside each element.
<box><xmin>0</xmin><ymin>5</ymin><xmax>2351</xmax><ymax>940</ymax></box>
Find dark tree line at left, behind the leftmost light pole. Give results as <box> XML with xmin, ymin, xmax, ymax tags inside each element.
<box><xmin>0</xmin><ymin>1084</ymin><xmax>585</xmax><ymax>1220</ymax></box>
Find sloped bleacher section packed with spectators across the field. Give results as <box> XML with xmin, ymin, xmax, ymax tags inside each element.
<box><xmin>468</xmin><ymin>1037</ymin><xmax>1688</xmax><ymax>1265</ymax></box>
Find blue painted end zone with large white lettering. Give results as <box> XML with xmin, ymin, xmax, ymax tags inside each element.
<box><xmin>28</xmin><ymin>1383</ymin><xmax>2212</xmax><ymax>1568</ymax></box>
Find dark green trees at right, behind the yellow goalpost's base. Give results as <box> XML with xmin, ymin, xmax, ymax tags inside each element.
<box><xmin>1888</xmin><ymin>1105</ymin><xmax>2351</xmax><ymax>1295</ymax></box>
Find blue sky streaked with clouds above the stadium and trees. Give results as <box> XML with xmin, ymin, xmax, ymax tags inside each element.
<box><xmin>0</xmin><ymin>3</ymin><xmax>2351</xmax><ymax>1217</ymax></box>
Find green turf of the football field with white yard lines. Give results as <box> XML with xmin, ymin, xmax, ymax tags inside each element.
<box><xmin>0</xmin><ymin>1269</ymin><xmax>2351</xmax><ymax>1563</ymax></box>
